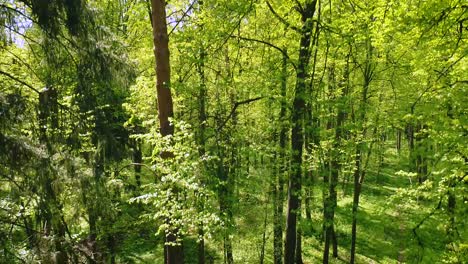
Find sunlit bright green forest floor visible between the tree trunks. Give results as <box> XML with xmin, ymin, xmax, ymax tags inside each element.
<box><xmin>135</xmin><ymin>148</ymin><xmax>445</xmax><ymax>264</ymax></box>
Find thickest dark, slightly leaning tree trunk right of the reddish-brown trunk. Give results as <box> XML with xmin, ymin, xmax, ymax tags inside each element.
<box><xmin>284</xmin><ymin>0</ymin><xmax>317</xmax><ymax>264</ymax></box>
